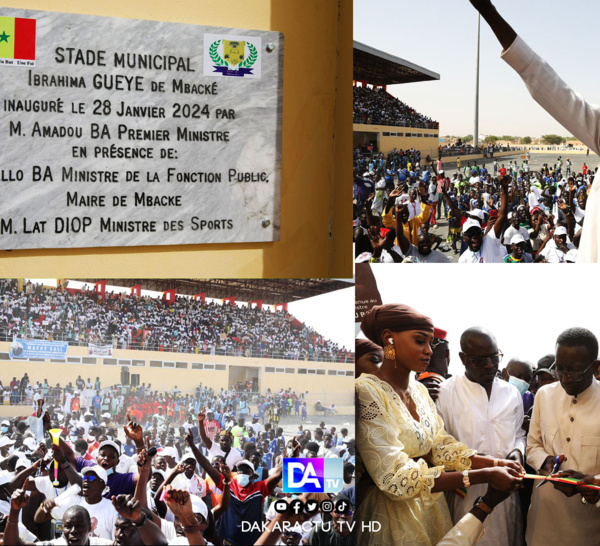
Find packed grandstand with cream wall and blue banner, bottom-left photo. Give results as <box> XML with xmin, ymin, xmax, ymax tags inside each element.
<box><xmin>0</xmin><ymin>279</ymin><xmax>354</xmax><ymax>415</ymax></box>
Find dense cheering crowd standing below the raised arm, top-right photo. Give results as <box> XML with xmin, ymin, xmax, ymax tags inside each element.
<box><xmin>354</xmin><ymin>153</ymin><xmax>597</xmax><ymax>263</ymax></box>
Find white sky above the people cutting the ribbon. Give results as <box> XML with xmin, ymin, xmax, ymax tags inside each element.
<box><xmin>360</xmin><ymin>264</ymin><xmax>600</xmax><ymax>375</ymax></box>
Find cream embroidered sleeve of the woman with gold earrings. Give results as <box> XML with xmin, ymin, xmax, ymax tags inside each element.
<box><xmin>356</xmin><ymin>377</ymin><xmax>443</xmax><ymax>506</ymax></box>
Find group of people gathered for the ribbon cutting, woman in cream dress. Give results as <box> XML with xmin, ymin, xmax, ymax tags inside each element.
<box><xmin>356</xmin><ymin>304</ymin><xmax>600</xmax><ymax>546</ymax></box>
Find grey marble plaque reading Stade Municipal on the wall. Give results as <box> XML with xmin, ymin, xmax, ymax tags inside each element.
<box><xmin>0</xmin><ymin>8</ymin><xmax>283</xmax><ymax>249</ymax></box>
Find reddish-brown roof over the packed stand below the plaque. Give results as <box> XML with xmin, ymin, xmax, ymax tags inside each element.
<box><xmin>77</xmin><ymin>279</ymin><xmax>354</xmax><ymax>305</ymax></box>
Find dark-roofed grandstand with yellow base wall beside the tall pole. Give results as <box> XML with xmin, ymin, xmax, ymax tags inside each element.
<box><xmin>353</xmin><ymin>41</ymin><xmax>440</xmax><ymax>156</ymax></box>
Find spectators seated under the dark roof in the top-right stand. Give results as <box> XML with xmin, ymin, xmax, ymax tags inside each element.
<box><xmin>352</xmin><ymin>86</ymin><xmax>439</xmax><ymax>129</ymax></box>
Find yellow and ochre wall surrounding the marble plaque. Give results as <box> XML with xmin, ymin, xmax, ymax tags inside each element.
<box><xmin>0</xmin><ymin>0</ymin><xmax>353</xmax><ymax>278</ymax></box>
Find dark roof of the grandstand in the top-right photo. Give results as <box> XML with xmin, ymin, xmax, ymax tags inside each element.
<box><xmin>353</xmin><ymin>41</ymin><xmax>440</xmax><ymax>85</ymax></box>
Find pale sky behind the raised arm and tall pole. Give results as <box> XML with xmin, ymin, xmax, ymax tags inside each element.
<box><xmin>354</xmin><ymin>0</ymin><xmax>600</xmax><ymax>137</ymax></box>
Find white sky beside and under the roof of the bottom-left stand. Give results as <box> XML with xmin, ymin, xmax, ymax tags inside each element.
<box><xmin>31</xmin><ymin>279</ymin><xmax>354</xmax><ymax>349</ymax></box>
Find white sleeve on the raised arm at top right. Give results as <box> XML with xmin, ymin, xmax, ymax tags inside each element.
<box><xmin>502</xmin><ymin>36</ymin><xmax>600</xmax><ymax>155</ymax></box>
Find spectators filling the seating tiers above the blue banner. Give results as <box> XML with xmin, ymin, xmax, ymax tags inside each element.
<box><xmin>0</xmin><ymin>279</ymin><xmax>353</xmax><ymax>362</ymax></box>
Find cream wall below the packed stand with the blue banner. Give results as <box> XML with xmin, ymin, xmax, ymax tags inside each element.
<box><xmin>0</xmin><ymin>342</ymin><xmax>354</xmax><ymax>406</ymax></box>
